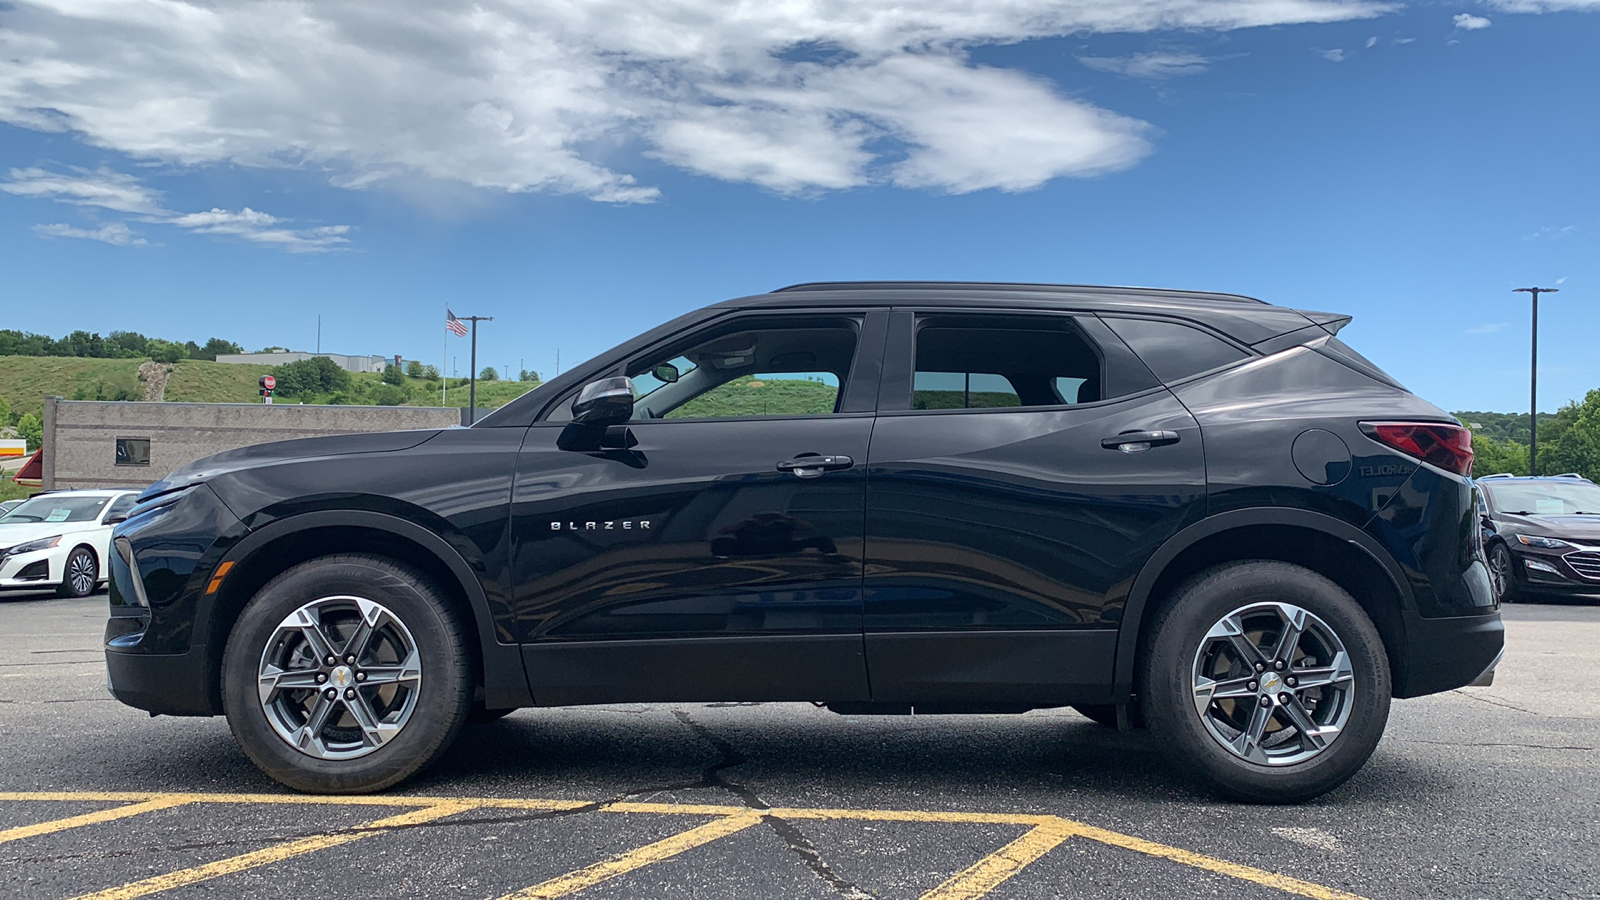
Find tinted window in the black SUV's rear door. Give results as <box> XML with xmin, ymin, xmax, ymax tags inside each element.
<box><xmin>912</xmin><ymin>315</ymin><xmax>1101</xmax><ymax>410</ymax></box>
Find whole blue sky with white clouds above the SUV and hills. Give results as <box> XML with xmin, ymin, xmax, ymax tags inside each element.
<box><xmin>0</xmin><ymin>0</ymin><xmax>1600</xmax><ymax>412</ymax></box>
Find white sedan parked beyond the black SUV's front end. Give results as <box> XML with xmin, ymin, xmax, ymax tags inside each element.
<box><xmin>0</xmin><ymin>490</ymin><xmax>138</xmax><ymax>597</ymax></box>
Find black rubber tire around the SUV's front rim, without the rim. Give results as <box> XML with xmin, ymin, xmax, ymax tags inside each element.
<box><xmin>222</xmin><ymin>554</ymin><xmax>474</xmax><ymax>794</ymax></box>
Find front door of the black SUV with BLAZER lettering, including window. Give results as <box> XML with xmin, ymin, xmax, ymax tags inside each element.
<box><xmin>512</xmin><ymin>311</ymin><xmax>886</xmax><ymax>705</ymax></box>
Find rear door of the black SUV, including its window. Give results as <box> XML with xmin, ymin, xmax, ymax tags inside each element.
<box><xmin>866</xmin><ymin>309</ymin><xmax>1205</xmax><ymax>709</ymax></box>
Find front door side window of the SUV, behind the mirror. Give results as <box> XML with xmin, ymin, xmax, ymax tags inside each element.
<box><xmin>627</xmin><ymin>315</ymin><xmax>859</xmax><ymax>420</ymax></box>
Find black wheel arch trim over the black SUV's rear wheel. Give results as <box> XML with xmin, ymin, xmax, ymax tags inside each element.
<box><xmin>1115</xmin><ymin>508</ymin><xmax>1416</xmax><ymax>700</ymax></box>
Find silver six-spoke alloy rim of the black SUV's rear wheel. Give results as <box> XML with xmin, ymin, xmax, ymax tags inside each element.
<box><xmin>1192</xmin><ymin>602</ymin><xmax>1355</xmax><ymax>765</ymax></box>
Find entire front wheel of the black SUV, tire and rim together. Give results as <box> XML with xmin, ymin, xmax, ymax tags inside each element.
<box><xmin>222</xmin><ymin>554</ymin><xmax>474</xmax><ymax>793</ymax></box>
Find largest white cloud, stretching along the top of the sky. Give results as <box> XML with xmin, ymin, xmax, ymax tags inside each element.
<box><xmin>0</xmin><ymin>0</ymin><xmax>1394</xmax><ymax>202</ymax></box>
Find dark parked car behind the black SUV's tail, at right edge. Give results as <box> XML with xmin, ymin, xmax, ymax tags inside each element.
<box><xmin>1478</xmin><ymin>474</ymin><xmax>1600</xmax><ymax>602</ymax></box>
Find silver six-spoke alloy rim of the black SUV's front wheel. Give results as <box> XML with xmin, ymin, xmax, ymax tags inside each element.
<box><xmin>256</xmin><ymin>596</ymin><xmax>422</xmax><ymax>759</ymax></box>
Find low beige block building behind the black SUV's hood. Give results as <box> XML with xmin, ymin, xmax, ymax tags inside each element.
<box><xmin>43</xmin><ymin>397</ymin><xmax>461</xmax><ymax>490</ymax></box>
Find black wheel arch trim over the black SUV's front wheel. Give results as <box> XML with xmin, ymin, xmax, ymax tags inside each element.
<box><xmin>195</xmin><ymin>511</ymin><xmax>533</xmax><ymax>709</ymax></box>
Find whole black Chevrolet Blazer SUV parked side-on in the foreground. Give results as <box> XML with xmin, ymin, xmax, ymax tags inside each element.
<box><xmin>106</xmin><ymin>283</ymin><xmax>1504</xmax><ymax>801</ymax></box>
